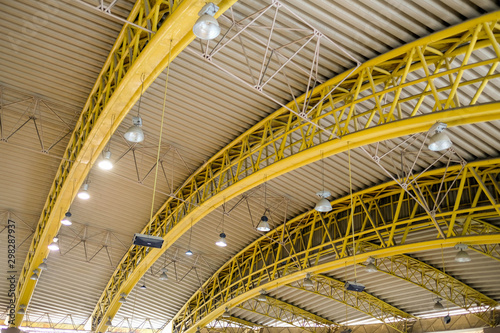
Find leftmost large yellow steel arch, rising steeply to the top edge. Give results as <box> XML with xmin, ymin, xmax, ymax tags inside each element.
<box><xmin>9</xmin><ymin>0</ymin><xmax>237</xmax><ymax>326</ymax></box>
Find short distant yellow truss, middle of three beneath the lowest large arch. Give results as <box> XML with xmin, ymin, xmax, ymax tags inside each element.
<box><xmin>288</xmin><ymin>274</ymin><xmax>416</xmax><ymax>333</ymax></box>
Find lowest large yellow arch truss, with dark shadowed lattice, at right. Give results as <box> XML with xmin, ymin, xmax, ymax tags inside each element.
<box><xmin>174</xmin><ymin>159</ymin><xmax>500</xmax><ymax>332</ymax></box>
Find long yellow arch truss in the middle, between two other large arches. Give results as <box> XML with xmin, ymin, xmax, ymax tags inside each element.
<box><xmin>90</xmin><ymin>12</ymin><xmax>500</xmax><ymax>331</ymax></box>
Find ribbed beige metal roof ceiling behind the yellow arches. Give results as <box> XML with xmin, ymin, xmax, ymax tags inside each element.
<box><xmin>0</xmin><ymin>0</ymin><xmax>500</xmax><ymax>328</ymax></box>
